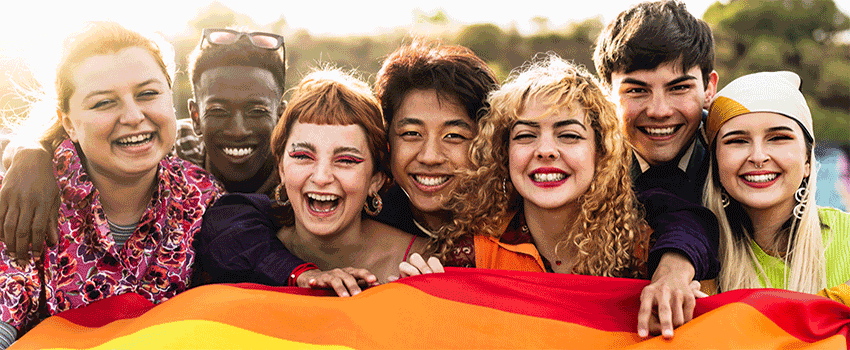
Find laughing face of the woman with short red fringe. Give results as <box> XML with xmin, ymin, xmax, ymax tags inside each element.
<box><xmin>280</xmin><ymin>122</ymin><xmax>384</xmax><ymax>236</ymax></box>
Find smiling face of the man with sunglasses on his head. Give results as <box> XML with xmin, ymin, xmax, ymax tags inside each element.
<box><xmin>189</xmin><ymin>66</ymin><xmax>282</xmax><ymax>185</ymax></box>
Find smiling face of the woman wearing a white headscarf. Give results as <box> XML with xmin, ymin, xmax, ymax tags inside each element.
<box><xmin>715</xmin><ymin>112</ymin><xmax>811</xmax><ymax>215</ymax></box>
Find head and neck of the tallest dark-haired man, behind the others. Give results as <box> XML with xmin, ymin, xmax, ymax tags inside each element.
<box><xmin>593</xmin><ymin>1</ymin><xmax>718</xmax><ymax>203</ymax></box>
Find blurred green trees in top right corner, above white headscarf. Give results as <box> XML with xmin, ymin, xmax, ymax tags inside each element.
<box><xmin>703</xmin><ymin>0</ymin><xmax>850</xmax><ymax>143</ymax></box>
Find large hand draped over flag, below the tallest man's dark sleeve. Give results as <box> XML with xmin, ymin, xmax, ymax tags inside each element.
<box><xmin>637</xmin><ymin>252</ymin><xmax>705</xmax><ymax>339</ymax></box>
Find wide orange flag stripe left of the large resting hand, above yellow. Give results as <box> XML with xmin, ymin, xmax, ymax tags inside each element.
<box><xmin>16</xmin><ymin>284</ymin><xmax>640</xmax><ymax>349</ymax></box>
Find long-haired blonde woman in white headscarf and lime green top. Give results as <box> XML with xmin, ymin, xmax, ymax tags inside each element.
<box><xmin>703</xmin><ymin>72</ymin><xmax>850</xmax><ymax>304</ymax></box>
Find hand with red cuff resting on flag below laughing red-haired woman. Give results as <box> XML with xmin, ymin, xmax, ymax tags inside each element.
<box><xmin>295</xmin><ymin>267</ymin><xmax>378</xmax><ymax>297</ymax></box>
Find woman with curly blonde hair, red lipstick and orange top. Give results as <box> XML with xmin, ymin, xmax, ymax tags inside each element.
<box><xmin>430</xmin><ymin>54</ymin><xmax>649</xmax><ymax>277</ymax></box>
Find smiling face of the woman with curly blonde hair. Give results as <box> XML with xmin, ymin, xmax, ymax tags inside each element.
<box><xmin>508</xmin><ymin>100</ymin><xmax>596</xmax><ymax>210</ymax></box>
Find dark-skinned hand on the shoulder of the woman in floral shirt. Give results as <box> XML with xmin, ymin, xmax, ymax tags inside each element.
<box><xmin>0</xmin><ymin>148</ymin><xmax>59</xmax><ymax>266</ymax></box>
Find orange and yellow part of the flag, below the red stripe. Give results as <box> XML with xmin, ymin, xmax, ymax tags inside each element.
<box><xmin>16</xmin><ymin>284</ymin><xmax>847</xmax><ymax>349</ymax></box>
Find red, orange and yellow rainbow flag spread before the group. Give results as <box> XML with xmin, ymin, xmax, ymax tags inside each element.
<box><xmin>13</xmin><ymin>268</ymin><xmax>850</xmax><ymax>349</ymax></box>
